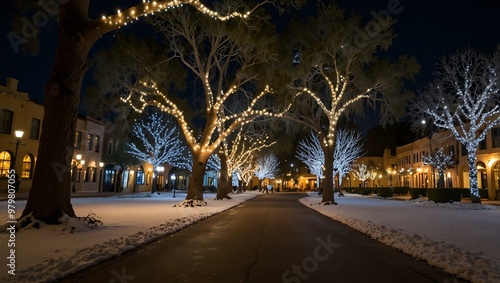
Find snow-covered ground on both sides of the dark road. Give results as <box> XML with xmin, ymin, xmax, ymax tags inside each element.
<box><xmin>0</xmin><ymin>192</ymin><xmax>500</xmax><ymax>282</ymax></box>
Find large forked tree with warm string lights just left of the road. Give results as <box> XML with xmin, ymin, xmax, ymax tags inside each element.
<box><xmin>126</xmin><ymin>5</ymin><xmax>290</xmax><ymax>203</ymax></box>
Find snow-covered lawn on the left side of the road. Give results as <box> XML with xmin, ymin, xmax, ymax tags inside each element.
<box><xmin>0</xmin><ymin>192</ymin><xmax>258</xmax><ymax>282</ymax></box>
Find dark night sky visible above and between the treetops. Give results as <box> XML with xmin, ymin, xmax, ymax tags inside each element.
<box><xmin>0</xmin><ymin>0</ymin><xmax>500</xmax><ymax>105</ymax></box>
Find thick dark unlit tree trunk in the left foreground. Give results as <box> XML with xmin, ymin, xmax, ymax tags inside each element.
<box><xmin>21</xmin><ymin>1</ymin><xmax>99</xmax><ymax>224</ymax></box>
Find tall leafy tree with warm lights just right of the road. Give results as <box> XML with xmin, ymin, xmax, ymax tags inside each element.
<box><xmin>283</xmin><ymin>3</ymin><xmax>419</xmax><ymax>204</ymax></box>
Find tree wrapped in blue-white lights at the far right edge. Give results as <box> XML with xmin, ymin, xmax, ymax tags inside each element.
<box><xmin>410</xmin><ymin>49</ymin><xmax>500</xmax><ymax>203</ymax></box>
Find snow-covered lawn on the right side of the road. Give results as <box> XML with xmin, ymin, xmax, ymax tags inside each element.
<box><xmin>300</xmin><ymin>193</ymin><xmax>500</xmax><ymax>282</ymax></box>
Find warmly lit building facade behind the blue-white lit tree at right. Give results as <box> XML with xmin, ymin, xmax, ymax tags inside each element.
<box><xmin>394</xmin><ymin>126</ymin><xmax>500</xmax><ymax>200</ymax></box>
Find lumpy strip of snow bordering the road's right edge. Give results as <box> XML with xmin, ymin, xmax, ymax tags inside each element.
<box><xmin>300</xmin><ymin>197</ymin><xmax>500</xmax><ymax>283</ymax></box>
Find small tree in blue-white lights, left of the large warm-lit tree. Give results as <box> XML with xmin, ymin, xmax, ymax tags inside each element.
<box><xmin>127</xmin><ymin>113</ymin><xmax>187</xmax><ymax>193</ymax></box>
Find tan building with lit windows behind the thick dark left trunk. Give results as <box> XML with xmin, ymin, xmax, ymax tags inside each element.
<box><xmin>0</xmin><ymin>78</ymin><xmax>104</xmax><ymax>196</ymax></box>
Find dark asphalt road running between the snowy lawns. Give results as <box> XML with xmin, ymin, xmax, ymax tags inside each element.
<box><xmin>63</xmin><ymin>193</ymin><xmax>462</xmax><ymax>283</ymax></box>
